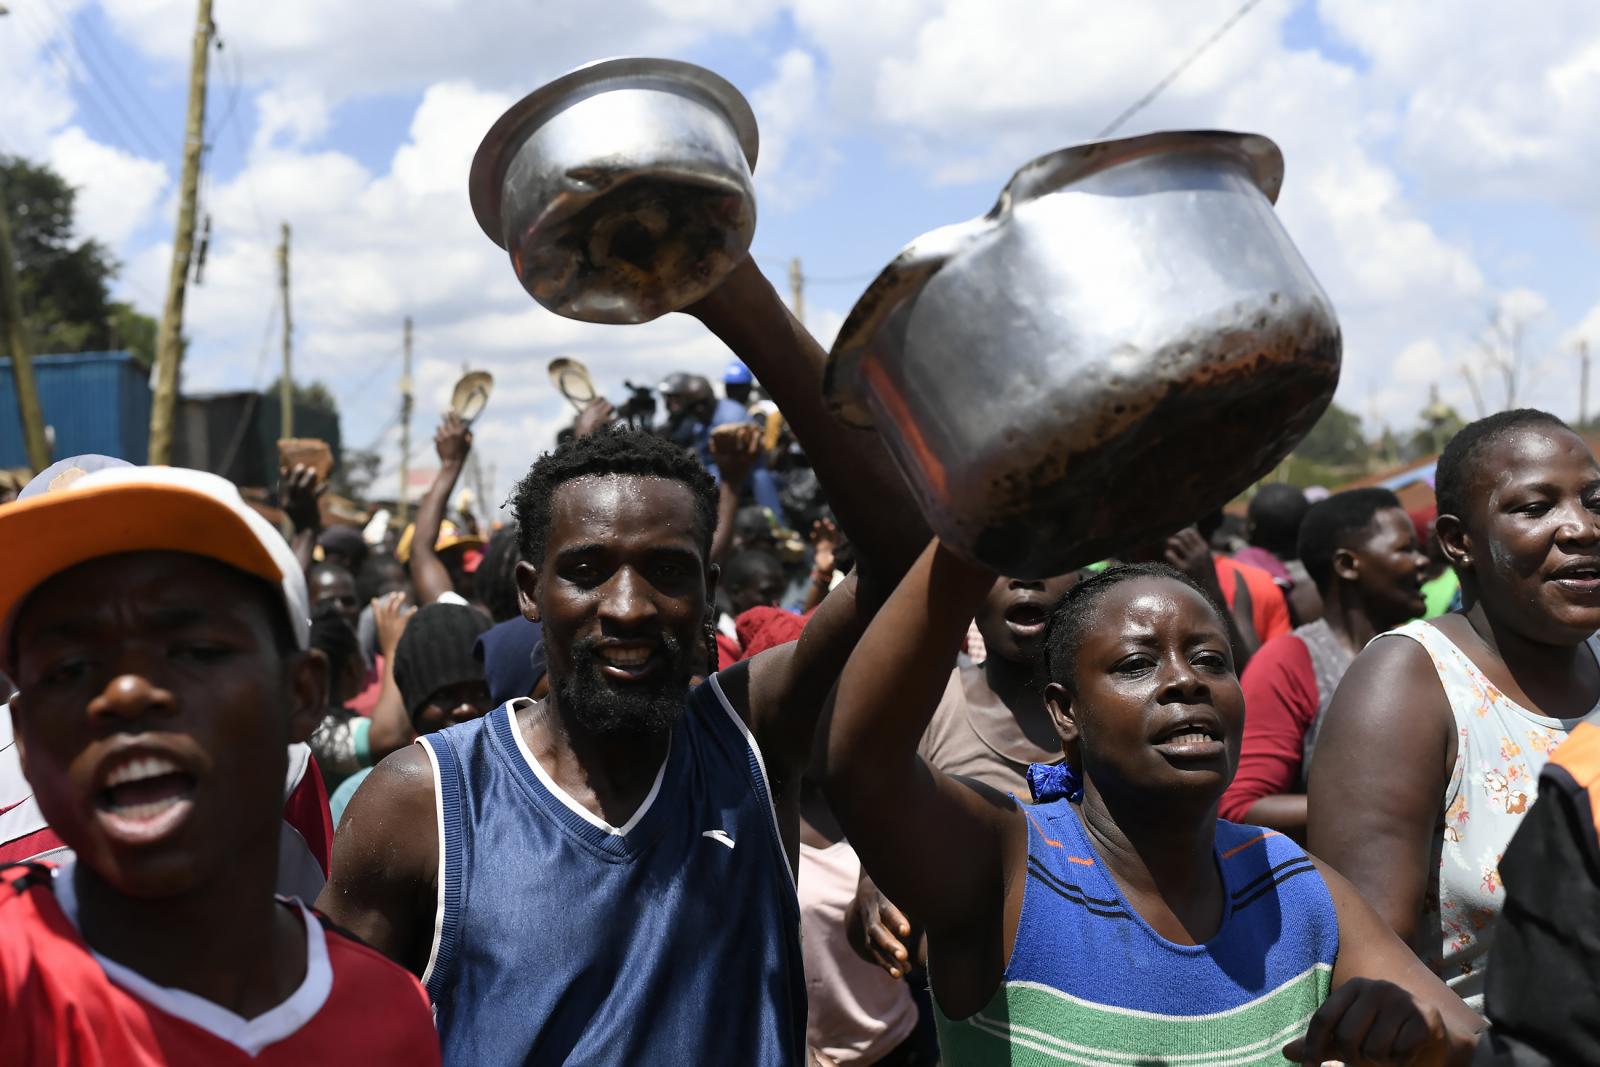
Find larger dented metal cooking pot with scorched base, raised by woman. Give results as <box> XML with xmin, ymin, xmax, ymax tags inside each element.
<box><xmin>824</xmin><ymin>131</ymin><xmax>1339</xmax><ymax>577</ymax></box>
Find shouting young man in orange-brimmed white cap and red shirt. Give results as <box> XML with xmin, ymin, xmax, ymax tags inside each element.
<box><xmin>0</xmin><ymin>467</ymin><xmax>438</xmax><ymax>1067</ymax></box>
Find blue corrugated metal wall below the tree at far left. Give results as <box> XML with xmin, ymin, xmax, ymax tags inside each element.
<box><xmin>0</xmin><ymin>352</ymin><xmax>150</xmax><ymax>467</ymax></box>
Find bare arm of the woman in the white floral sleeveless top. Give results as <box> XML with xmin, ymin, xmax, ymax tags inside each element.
<box><xmin>1306</xmin><ymin>637</ymin><xmax>1454</xmax><ymax>944</ymax></box>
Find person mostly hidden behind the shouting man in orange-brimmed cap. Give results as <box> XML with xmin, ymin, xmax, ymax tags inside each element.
<box><xmin>0</xmin><ymin>454</ymin><xmax>333</xmax><ymax>901</ymax></box>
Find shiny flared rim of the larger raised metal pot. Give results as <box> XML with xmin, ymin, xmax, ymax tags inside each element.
<box><xmin>822</xmin><ymin>130</ymin><xmax>1283</xmax><ymax>430</ymax></box>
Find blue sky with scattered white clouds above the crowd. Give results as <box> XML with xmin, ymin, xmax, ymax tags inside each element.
<box><xmin>0</xmin><ymin>0</ymin><xmax>1600</xmax><ymax>508</ymax></box>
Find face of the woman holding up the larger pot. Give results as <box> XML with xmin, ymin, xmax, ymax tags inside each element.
<box><xmin>1046</xmin><ymin>577</ymin><xmax>1245</xmax><ymax>803</ymax></box>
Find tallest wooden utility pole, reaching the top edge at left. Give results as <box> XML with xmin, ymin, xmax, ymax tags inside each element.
<box><xmin>150</xmin><ymin>0</ymin><xmax>213</xmax><ymax>464</ymax></box>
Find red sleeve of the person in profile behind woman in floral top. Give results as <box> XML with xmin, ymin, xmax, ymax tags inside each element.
<box><xmin>1218</xmin><ymin>633</ymin><xmax>1322</xmax><ymax>822</ymax></box>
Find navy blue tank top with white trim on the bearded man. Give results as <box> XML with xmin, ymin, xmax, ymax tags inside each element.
<box><xmin>421</xmin><ymin>677</ymin><xmax>806</xmax><ymax>1067</ymax></box>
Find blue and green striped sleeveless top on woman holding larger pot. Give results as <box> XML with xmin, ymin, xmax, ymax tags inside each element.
<box><xmin>933</xmin><ymin>800</ymin><xmax>1339</xmax><ymax>1067</ymax></box>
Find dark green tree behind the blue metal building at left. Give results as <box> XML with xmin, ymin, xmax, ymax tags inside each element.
<box><xmin>0</xmin><ymin>155</ymin><xmax>155</xmax><ymax>368</ymax></box>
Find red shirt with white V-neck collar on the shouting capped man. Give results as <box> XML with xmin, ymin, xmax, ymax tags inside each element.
<box><xmin>0</xmin><ymin>864</ymin><xmax>438</xmax><ymax>1067</ymax></box>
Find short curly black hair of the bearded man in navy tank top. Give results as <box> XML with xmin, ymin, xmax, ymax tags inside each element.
<box><xmin>510</xmin><ymin>427</ymin><xmax>717</xmax><ymax>566</ymax></box>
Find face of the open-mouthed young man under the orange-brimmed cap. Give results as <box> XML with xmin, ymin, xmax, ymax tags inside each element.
<box><xmin>11</xmin><ymin>552</ymin><xmax>326</xmax><ymax>897</ymax></box>
